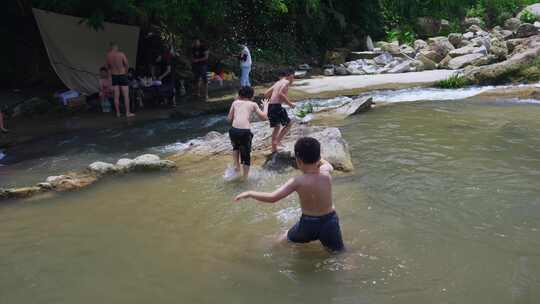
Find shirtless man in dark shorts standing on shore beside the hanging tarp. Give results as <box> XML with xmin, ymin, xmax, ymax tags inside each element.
<box><xmin>107</xmin><ymin>42</ymin><xmax>135</xmax><ymax>117</ymax></box>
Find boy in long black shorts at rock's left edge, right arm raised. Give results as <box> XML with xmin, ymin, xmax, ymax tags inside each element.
<box><xmin>228</xmin><ymin>87</ymin><xmax>268</xmax><ymax>179</ymax></box>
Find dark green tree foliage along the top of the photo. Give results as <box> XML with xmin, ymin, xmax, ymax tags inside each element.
<box><xmin>28</xmin><ymin>0</ymin><xmax>536</xmax><ymax>60</ymax></box>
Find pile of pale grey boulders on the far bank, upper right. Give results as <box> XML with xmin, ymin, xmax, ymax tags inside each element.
<box><xmin>324</xmin><ymin>10</ymin><xmax>540</xmax><ymax>83</ymax></box>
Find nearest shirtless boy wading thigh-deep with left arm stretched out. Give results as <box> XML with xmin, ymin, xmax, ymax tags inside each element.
<box><xmin>235</xmin><ymin>137</ymin><xmax>344</xmax><ymax>252</ymax></box>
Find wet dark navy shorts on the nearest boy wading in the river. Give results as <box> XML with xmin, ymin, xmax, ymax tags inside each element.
<box><xmin>287</xmin><ymin>211</ymin><xmax>345</xmax><ymax>251</ymax></box>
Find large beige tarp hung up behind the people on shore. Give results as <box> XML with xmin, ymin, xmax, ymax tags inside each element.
<box><xmin>33</xmin><ymin>9</ymin><xmax>139</xmax><ymax>95</ymax></box>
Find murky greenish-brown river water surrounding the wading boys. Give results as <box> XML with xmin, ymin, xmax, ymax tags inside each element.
<box><xmin>0</xmin><ymin>91</ymin><xmax>540</xmax><ymax>304</ymax></box>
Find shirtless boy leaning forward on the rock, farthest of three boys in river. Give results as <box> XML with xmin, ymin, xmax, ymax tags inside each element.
<box><xmin>264</xmin><ymin>71</ymin><xmax>295</xmax><ymax>152</ymax></box>
